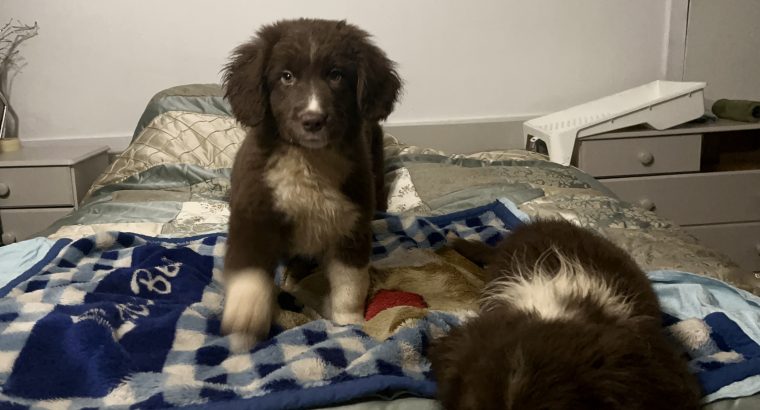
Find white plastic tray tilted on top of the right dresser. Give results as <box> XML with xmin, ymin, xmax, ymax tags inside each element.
<box><xmin>523</xmin><ymin>81</ymin><xmax>707</xmax><ymax>165</ymax></box>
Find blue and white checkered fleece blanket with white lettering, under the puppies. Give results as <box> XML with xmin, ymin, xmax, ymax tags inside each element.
<box><xmin>0</xmin><ymin>202</ymin><xmax>760</xmax><ymax>409</ymax></box>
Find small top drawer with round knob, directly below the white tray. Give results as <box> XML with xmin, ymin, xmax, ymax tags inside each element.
<box><xmin>578</xmin><ymin>134</ymin><xmax>702</xmax><ymax>177</ymax></box>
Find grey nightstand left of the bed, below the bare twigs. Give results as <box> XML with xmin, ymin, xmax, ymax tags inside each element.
<box><xmin>0</xmin><ymin>146</ymin><xmax>108</xmax><ymax>245</ymax></box>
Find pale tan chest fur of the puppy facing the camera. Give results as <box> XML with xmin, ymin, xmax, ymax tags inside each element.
<box><xmin>264</xmin><ymin>147</ymin><xmax>359</xmax><ymax>255</ymax></box>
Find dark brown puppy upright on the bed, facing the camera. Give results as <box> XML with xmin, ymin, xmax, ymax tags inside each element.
<box><xmin>222</xmin><ymin>19</ymin><xmax>401</xmax><ymax>348</ymax></box>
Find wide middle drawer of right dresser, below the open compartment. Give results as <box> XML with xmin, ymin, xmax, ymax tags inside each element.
<box><xmin>601</xmin><ymin>171</ymin><xmax>760</xmax><ymax>225</ymax></box>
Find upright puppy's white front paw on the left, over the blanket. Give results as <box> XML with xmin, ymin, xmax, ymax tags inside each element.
<box><xmin>222</xmin><ymin>269</ymin><xmax>275</xmax><ymax>352</ymax></box>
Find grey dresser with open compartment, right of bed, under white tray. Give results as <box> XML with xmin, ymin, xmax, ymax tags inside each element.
<box><xmin>574</xmin><ymin>120</ymin><xmax>760</xmax><ymax>272</ymax></box>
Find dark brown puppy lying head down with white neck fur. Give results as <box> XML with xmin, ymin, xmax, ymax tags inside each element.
<box><xmin>430</xmin><ymin>221</ymin><xmax>700</xmax><ymax>410</ymax></box>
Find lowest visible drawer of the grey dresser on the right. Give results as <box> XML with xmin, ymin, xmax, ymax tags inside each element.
<box><xmin>683</xmin><ymin>222</ymin><xmax>760</xmax><ymax>271</ymax></box>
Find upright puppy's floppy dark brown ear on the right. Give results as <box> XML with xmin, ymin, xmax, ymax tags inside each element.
<box><xmin>356</xmin><ymin>33</ymin><xmax>401</xmax><ymax>121</ymax></box>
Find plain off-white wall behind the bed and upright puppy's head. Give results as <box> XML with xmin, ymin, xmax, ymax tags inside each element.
<box><xmin>0</xmin><ymin>0</ymin><xmax>678</xmax><ymax>151</ymax></box>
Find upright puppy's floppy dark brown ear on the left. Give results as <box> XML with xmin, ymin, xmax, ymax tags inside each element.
<box><xmin>223</xmin><ymin>25</ymin><xmax>278</xmax><ymax>126</ymax></box>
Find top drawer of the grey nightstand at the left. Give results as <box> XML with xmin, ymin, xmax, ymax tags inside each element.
<box><xmin>0</xmin><ymin>167</ymin><xmax>76</xmax><ymax>208</ymax></box>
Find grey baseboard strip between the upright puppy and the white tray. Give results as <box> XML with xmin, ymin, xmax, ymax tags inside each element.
<box><xmin>383</xmin><ymin>116</ymin><xmax>535</xmax><ymax>154</ymax></box>
